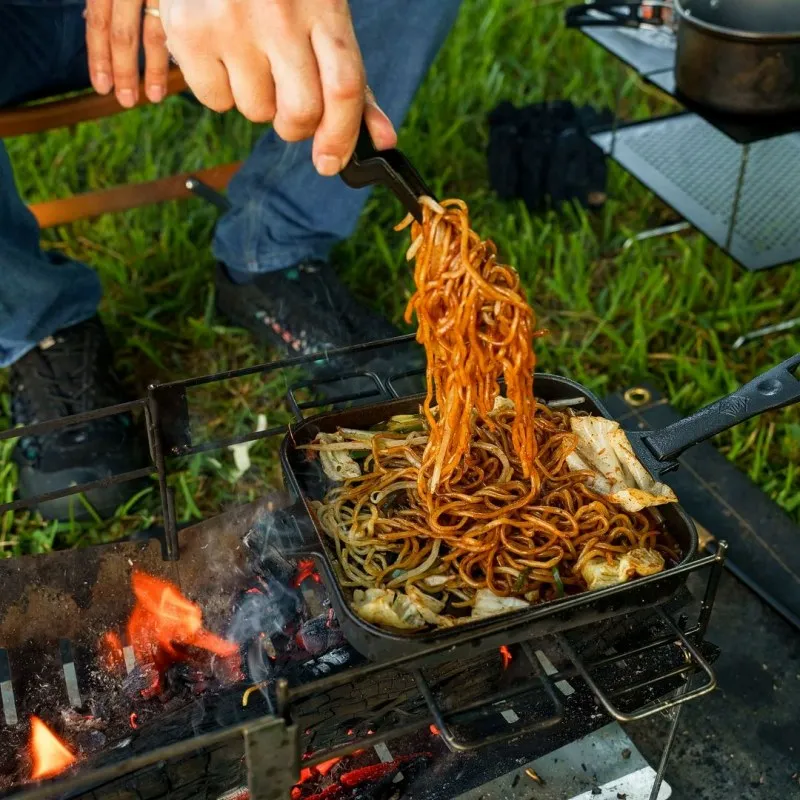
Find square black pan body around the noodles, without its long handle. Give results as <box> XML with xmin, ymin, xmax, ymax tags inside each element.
<box><xmin>281</xmin><ymin>374</ymin><xmax>697</xmax><ymax>667</ymax></box>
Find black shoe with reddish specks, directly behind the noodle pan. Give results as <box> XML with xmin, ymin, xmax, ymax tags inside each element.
<box><xmin>216</xmin><ymin>262</ymin><xmax>424</xmax><ymax>390</ymax></box>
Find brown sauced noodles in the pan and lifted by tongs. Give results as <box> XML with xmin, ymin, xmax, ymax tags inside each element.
<box><xmin>307</xmin><ymin>198</ymin><xmax>676</xmax><ymax>628</ymax></box>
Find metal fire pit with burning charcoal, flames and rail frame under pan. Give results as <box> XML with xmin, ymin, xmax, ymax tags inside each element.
<box><xmin>0</xmin><ymin>337</ymin><xmax>725</xmax><ymax>800</ymax></box>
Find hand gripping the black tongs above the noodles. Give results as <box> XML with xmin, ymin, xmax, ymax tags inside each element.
<box><xmin>159</xmin><ymin>0</ymin><xmax>397</xmax><ymax>175</ymax></box>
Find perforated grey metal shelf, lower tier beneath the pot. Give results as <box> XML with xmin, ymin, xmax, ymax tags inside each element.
<box><xmin>592</xmin><ymin>114</ymin><xmax>800</xmax><ymax>270</ymax></box>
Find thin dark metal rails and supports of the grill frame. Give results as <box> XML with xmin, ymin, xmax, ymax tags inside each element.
<box><xmin>0</xmin><ymin>335</ymin><xmax>727</xmax><ymax>800</ymax></box>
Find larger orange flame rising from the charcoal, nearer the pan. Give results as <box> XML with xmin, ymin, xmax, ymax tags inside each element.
<box><xmin>123</xmin><ymin>572</ymin><xmax>239</xmax><ymax>692</ymax></box>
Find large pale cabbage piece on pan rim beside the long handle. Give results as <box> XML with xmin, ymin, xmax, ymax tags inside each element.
<box><xmin>567</xmin><ymin>417</ymin><xmax>678</xmax><ymax>512</ymax></box>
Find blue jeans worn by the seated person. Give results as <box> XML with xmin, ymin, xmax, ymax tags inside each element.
<box><xmin>0</xmin><ymin>0</ymin><xmax>460</xmax><ymax>366</ymax></box>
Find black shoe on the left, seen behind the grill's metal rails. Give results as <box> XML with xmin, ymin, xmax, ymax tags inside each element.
<box><xmin>10</xmin><ymin>317</ymin><xmax>149</xmax><ymax>519</ymax></box>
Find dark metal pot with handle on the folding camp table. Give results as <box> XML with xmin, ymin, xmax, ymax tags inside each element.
<box><xmin>566</xmin><ymin>0</ymin><xmax>800</xmax><ymax>115</ymax></box>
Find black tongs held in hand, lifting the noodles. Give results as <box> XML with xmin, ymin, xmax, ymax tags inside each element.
<box><xmin>339</xmin><ymin>122</ymin><xmax>436</xmax><ymax>222</ymax></box>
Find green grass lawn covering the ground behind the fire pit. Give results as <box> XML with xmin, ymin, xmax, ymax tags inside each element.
<box><xmin>0</xmin><ymin>0</ymin><xmax>800</xmax><ymax>555</ymax></box>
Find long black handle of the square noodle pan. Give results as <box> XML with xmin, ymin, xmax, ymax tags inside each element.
<box><xmin>636</xmin><ymin>353</ymin><xmax>800</xmax><ymax>473</ymax></box>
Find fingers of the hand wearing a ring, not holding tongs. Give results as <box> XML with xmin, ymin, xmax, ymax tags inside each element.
<box><xmin>84</xmin><ymin>0</ymin><xmax>169</xmax><ymax>108</ymax></box>
